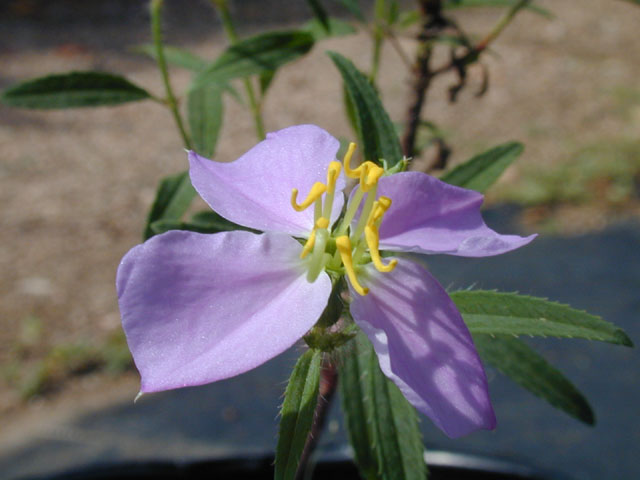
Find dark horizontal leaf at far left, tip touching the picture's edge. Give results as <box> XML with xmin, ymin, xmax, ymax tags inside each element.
<box><xmin>0</xmin><ymin>72</ymin><xmax>151</xmax><ymax>109</ymax></box>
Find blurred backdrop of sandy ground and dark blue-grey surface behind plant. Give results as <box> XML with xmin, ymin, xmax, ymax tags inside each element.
<box><xmin>0</xmin><ymin>0</ymin><xmax>640</xmax><ymax>478</ymax></box>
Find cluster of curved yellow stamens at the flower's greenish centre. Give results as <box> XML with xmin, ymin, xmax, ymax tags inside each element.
<box><xmin>291</xmin><ymin>143</ymin><xmax>398</xmax><ymax>295</ymax></box>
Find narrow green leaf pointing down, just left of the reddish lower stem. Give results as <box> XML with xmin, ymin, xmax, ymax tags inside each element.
<box><xmin>274</xmin><ymin>349</ymin><xmax>322</xmax><ymax>480</ymax></box>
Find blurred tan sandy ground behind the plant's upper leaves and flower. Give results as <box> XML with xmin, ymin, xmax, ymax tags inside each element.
<box><xmin>0</xmin><ymin>0</ymin><xmax>640</xmax><ymax>428</ymax></box>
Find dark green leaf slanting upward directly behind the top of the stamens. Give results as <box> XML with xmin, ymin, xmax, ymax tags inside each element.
<box><xmin>327</xmin><ymin>52</ymin><xmax>402</xmax><ymax>167</ymax></box>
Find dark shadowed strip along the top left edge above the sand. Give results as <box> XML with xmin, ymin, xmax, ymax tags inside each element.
<box><xmin>0</xmin><ymin>0</ymin><xmax>344</xmax><ymax>53</ymax></box>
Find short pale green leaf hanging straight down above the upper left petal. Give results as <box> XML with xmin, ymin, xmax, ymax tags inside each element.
<box><xmin>187</xmin><ymin>85</ymin><xmax>224</xmax><ymax>158</ymax></box>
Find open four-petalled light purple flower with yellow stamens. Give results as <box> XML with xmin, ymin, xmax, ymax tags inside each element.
<box><xmin>117</xmin><ymin>125</ymin><xmax>533</xmax><ymax>437</ymax></box>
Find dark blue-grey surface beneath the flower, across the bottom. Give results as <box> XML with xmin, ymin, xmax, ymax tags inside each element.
<box><xmin>0</xmin><ymin>209</ymin><xmax>640</xmax><ymax>480</ymax></box>
